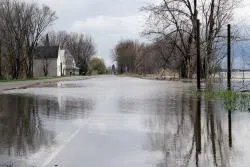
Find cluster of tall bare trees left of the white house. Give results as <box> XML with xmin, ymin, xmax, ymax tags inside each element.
<box><xmin>0</xmin><ymin>0</ymin><xmax>57</xmax><ymax>79</ymax></box>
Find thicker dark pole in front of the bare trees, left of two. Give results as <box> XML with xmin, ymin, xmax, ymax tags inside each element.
<box><xmin>196</xmin><ymin>19</ymin><xmax>201</xmax><ymax>90</ymax></box>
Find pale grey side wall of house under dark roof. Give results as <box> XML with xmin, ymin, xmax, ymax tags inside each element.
<box><xmin>33</xmin><ymin>58</ymin><xmax>57</xmax><ymax>77</ymax></box>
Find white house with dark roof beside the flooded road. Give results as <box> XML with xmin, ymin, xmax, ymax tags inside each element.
<box><xmin>33</xmin><ymin>46</ymin><xmax>79</xmax><ymax>77</ymax></box>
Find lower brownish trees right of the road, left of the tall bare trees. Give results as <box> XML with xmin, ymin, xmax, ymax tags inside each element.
<box><xmin>113</xmin><ymin>40</ymin><xmax>175</xmax><ymax>74</ymax></box>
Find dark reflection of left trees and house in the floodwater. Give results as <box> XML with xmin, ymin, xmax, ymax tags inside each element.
<box><xmin>0</xmin><ymin>95</ymin><xmax>93</xmax><ymax>166</ymax></box>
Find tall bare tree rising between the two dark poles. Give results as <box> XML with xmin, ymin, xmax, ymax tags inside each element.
<box><xmin>199</xmin><ymin>0</ymin><xmax>240</xmax><ymax>78</ymax></box>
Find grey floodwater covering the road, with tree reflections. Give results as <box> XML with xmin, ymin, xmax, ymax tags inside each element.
<box><xmin>0</xmin><ymin>76</ymin><xmax>250</xmax><ymax>167</ymax></box>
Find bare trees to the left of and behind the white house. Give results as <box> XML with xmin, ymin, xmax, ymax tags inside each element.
<box><xmin>0</xmin><ymin>0</ymin><xmax>95</xmax><ymax>79</ymax></box>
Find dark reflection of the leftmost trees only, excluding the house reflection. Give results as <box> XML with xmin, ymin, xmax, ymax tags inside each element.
<box><xmin>0</xmin><ymin>95</ymin><xmax>54</xmax><ymax>156</ymax></box>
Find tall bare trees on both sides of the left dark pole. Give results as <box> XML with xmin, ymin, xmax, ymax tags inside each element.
<box><xmin>143</xmin><ymin>0</ymin><xmax>238</xmax><ymax>78</ymax></box>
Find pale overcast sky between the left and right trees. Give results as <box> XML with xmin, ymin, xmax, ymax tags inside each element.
<box><xmin>27</xmin><ymin>0</ymin><xmax>250</xmax><ymax>65</ymax></box>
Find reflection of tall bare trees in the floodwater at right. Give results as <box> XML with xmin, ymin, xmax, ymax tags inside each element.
<box><xmin>147</xmin><ymin>94</ymin><xmax>232</xmax><ymax>167</ymax></box>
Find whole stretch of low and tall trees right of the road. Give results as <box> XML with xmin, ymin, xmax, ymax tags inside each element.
<box><xmin>115</xmin><ymin>0</ymin><xmax>240</xmax><ymax>78</ymax></box>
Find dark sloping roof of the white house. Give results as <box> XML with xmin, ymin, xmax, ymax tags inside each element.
<box><xmin>35</xmin><ymin>46</ymin><xmax>59</xmax><ymax>59</ymax></box>
